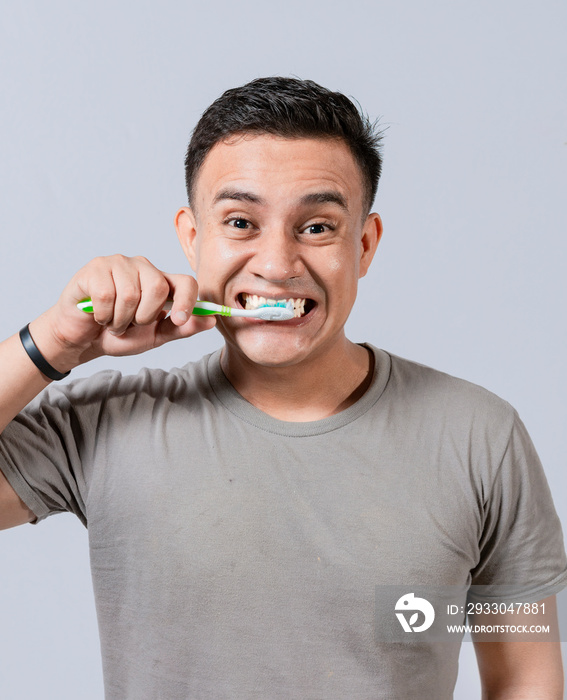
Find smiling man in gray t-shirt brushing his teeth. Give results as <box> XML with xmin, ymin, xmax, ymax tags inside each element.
<box><xmin>0</xmin><ymin>78</ymin><xmax>567</xmax><ymax>700</ymax></box>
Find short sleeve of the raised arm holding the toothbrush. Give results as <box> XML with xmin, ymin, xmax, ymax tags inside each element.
<box><xmin>0</xmin><ymin>373</ymin><xmax>114</xmax><ymax>526</ymax></box>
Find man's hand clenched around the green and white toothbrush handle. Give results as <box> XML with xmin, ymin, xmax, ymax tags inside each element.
<box><xmin>30</xmin><ymin>255</ymin><xmax>215</xmax><ymax>372</ymax></box>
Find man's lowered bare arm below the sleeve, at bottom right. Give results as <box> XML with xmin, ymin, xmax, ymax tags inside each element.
<box><xmin>470</xmin><ymin>596</ymin><xmax>564</xmax><ymax>700</ymax></box>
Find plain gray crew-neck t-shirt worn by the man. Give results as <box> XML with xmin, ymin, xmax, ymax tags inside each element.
<box><xmin>0</xmin><ymin>346</ymin><xmax>567</xmax><ymax>700</ymax></box>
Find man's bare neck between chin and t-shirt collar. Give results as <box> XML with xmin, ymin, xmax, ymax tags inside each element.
<box><xmin>221</xmin><ymin>338</ymin><xmax>374</xmax><ymax>422</ymax></box>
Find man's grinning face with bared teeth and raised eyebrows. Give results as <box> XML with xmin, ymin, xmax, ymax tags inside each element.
<box><xmin>176</xmin><ymin>134</ymin><xmax>381</xmax><ymax>366</ymax></box>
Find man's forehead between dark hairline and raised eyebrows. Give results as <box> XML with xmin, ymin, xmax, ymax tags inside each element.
<box><xmin>194</xmin><ymin>134</ymin><xmax>363</xmax><ymax>213</ymax></box>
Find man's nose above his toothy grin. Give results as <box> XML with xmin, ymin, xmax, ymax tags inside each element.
<box><xmin>249</xmin><ymin>226</ymin><xmax>304</xmax><ymax>283</ymax></box>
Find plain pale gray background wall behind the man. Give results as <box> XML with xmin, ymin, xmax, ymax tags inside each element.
<box><xmin>0</xmin><ymin>0</ymin><xmax>567</xmax><ymax>700</ymax></box>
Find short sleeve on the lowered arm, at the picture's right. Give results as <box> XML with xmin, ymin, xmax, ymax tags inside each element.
<box><xmin>471</xmin><ymin>411</ymin><xmax>567</xmax><ymax>602</ymax></box>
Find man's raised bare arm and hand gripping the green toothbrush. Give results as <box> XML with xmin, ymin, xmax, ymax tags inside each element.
<box><xmin>0</xmin><ymin>255</ymin><xmax>215</xmax><ymax>530</ymax></box>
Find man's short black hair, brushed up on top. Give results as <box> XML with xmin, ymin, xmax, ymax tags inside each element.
<box><xmin>185</xmin><ymin>76</ymin><xmax>382</xmax><ymax>214</ymax></box>
